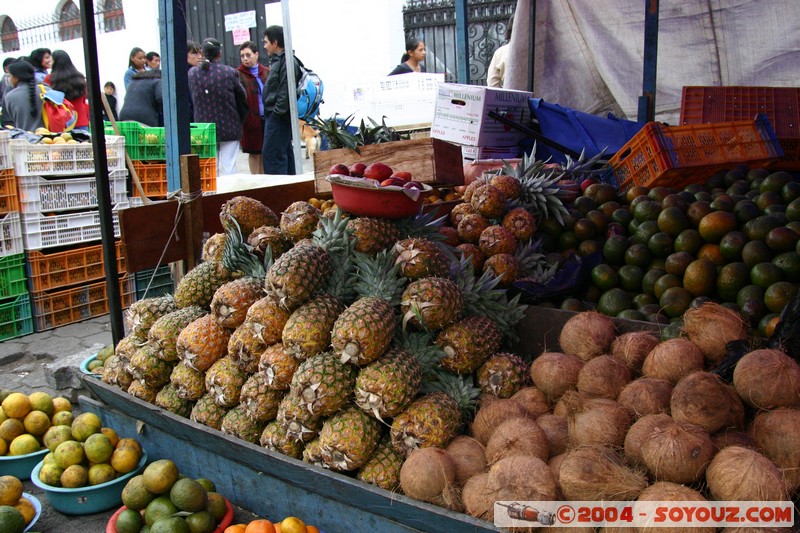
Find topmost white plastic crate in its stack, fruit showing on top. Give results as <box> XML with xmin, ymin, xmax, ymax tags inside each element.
<box><xmin>11</xmin><ymin>136</ymin><xmax>125</xmax><ymax>176</ymax></box>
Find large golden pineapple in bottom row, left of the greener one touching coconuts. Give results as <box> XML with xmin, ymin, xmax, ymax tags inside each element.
<box><xmin>319</xmin><ymin>407</ymin><xmax>381</xmax><ymax>471</ymax></box>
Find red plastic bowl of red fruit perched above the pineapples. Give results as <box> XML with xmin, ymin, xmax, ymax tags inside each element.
<box><xmin>330</xmin><ymin>177</ymin><xmax>433</xmax><ymax>218</ymax></box>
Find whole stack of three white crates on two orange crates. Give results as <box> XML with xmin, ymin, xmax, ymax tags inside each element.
<box><xmin>11</xmin><ymin>137</ymin><xmax>133</xmax><ymax>331</ymax></box>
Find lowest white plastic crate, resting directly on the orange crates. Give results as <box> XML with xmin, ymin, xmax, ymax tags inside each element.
<box><xmin>22</xmin><ymin>204</ymin><xmax>127</xmax><ymax>250</ymax></box>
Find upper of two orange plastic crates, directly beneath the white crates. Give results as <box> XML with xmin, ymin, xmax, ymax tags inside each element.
<box><xmin>27</xmin><ymin>241</ymin><xmax>127</xmax><ymax>292</ymax></box>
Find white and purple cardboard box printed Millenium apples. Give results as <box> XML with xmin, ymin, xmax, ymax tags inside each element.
<box><xmin>431</xmin><ymin>83</ymin><xmax>533</xmax><ymax>146</ymax></box>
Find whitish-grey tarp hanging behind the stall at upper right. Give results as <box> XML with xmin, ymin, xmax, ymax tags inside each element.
<box><xmin>505</xmin><ymin>0</ymin><xmax>800</xmax><ymax>124</ymax></box>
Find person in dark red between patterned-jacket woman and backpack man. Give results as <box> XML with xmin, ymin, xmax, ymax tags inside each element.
<box><xmin>236</xmin><ymin>41</ymin><xmax>269</xmax><ymax>174</ymax></box>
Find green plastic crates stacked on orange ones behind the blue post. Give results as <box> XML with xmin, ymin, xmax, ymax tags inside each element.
<box><xmin>106</xmin><ymin>121</ymin><xmax>217</xmax><ymax>198</ymax></box>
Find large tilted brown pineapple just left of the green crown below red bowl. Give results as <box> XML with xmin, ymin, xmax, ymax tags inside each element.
<box><xmin>266</xmin><ymin>244</ymin><xmax>333</xmax><ymax>309</ymax></box>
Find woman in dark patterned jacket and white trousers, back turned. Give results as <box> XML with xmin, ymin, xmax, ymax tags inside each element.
<box><xmin>189</xmin><ymin>38</ymin><xmax>247</xmax><ymax>176</ymax></box>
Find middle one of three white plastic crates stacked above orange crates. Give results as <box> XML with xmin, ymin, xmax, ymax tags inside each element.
<box><xmin>17</xmin><ymin>170</ymin><xmax>128</xmax><ymax>214</ymax></box>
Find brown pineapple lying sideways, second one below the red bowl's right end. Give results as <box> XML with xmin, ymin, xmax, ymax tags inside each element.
<box><xmin>400</xmin><ymin>278</ymin><xmax>464</xmax><ymax>330</ymax></box>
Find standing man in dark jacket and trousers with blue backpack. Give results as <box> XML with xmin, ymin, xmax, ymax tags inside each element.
<box><xmin>263</xmin><ymin>26</ymin><xmax>301</xmax><ymax>175</ymax></box>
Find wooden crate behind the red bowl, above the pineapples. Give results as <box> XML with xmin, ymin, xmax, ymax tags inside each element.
<box><xmin>314</xmin><ymin>138</ymin><xmax>464</xmax><ymax>193</ymax></box>
